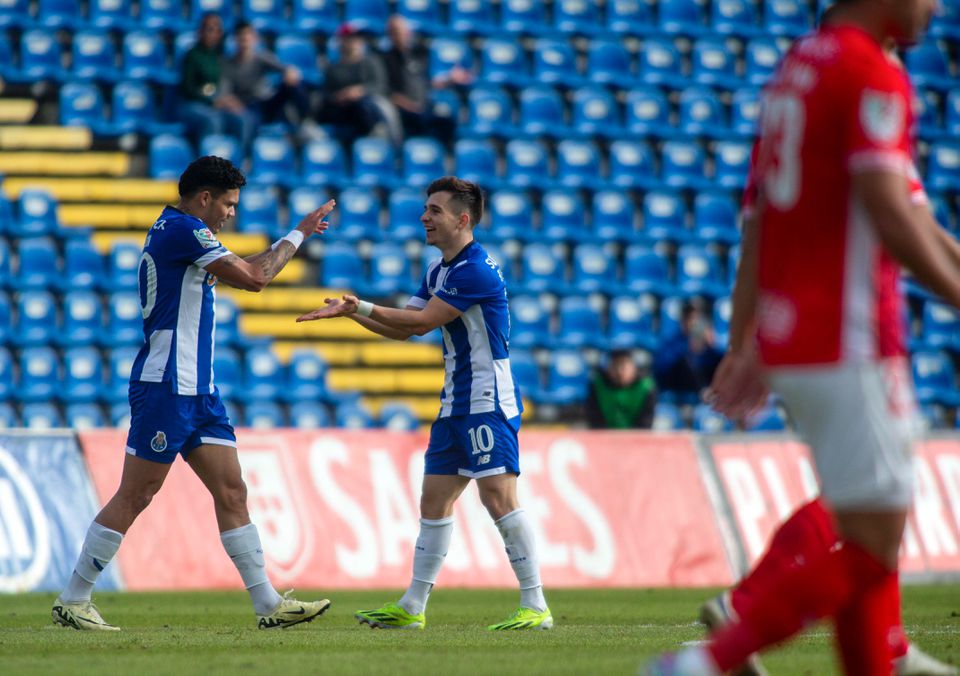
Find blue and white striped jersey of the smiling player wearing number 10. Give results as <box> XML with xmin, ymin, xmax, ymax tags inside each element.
<box><xmin>408</xmin><ymin>242</ymin><xmax>523</xmax><ymax>419</ymax></box>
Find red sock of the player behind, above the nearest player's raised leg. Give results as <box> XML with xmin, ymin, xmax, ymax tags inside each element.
<box><xmin>730</xmin><ymin>499</ymin><xmax>839</xmax><ymax>614</ymax></box>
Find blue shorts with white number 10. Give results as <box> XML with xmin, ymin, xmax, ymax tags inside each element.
<box><xmin>424</xmin><ymin>411</ymin><xmax>520</xmax><ymax>479</ymax></box>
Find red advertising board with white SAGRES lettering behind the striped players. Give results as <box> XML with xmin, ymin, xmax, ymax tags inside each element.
<box><xmin>80</xmin><ymin>430</ymin><xmax>733</xmax><ymax>589</ymax></box>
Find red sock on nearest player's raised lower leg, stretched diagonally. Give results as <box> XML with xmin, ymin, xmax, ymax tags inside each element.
<box><xmin>708</xmin><ymin>543</ymin><xmax>890</xmax><ymax>671</ymax></box>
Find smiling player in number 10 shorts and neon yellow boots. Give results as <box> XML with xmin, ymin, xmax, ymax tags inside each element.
<box><xmin>297</xmin><ymin>176</ymin><xmax>553</xmax><ymax>631</ymax></box>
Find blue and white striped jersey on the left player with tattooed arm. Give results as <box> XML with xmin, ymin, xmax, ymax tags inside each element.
<box><xmin>130</xmin><ymin>206</ymin><xmax>230</xmax><ymax>395</ymax></box>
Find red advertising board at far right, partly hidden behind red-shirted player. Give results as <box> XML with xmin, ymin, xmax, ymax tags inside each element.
<box><xmin>710</xmin><ymin>438</ymin><xmax>960</xmax><ymax>573</ymax></box>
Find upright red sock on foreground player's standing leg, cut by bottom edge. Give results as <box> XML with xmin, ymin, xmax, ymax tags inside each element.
<box><xmin>836</xmin><ymin>564</ymin><xmax>902</xmax><ymax>676</ymax></box>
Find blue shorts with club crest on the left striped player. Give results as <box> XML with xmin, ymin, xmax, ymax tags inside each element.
<box><xmin>127</xmin><ymin>382</ymin><xmax>237</xmax><ymax>465</ymax></box>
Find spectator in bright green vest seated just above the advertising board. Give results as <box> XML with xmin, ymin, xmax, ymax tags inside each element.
<box><xmin>586</xmin><ymin>350</ymin><xmax>657</xmax><ymax>430</ymax></box>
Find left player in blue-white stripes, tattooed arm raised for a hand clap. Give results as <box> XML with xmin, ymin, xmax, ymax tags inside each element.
<box><xmin>52</xmin><ymin>156</ymin><xmax>334</xmax><ymax>631</ymax></box>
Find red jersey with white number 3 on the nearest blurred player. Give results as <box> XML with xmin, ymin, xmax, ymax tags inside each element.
<box><xmin>754</xmin><ymin>26</ymin><xmax>913</xmax><ymax>366</ymax></box>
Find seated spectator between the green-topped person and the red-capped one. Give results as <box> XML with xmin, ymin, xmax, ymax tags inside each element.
<box><xmin>223</xmin><ymin>21</ymin><xmax>308</xmax><ymax>148</ymax></box>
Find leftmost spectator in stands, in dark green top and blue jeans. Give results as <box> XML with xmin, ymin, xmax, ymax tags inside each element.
<box><xmin>179</xmin><ymin>13</ymin><xmax>251</xmax><ymax>142</ymax></box>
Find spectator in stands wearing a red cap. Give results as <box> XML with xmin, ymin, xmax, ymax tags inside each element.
<box><xmin>318</xmin><ymin>23</ymin><xmax>402</xmax><ymax>143</ymax></box>
